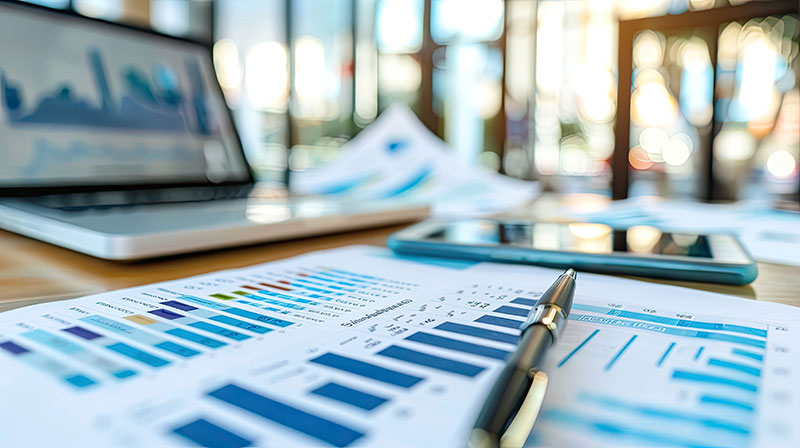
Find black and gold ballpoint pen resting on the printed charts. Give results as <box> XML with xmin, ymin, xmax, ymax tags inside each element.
<box><xmin>469</xmin><ymin>269</ymin><xmax>576</xmax><ymax>448</ymax></box>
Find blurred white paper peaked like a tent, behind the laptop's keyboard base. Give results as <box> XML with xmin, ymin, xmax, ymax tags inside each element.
<box><xmin>290</xmin><ymin>106</ymin><xmax>540</xmax><ymax>216</ymax></box>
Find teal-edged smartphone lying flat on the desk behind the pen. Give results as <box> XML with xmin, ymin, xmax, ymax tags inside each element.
<box><xmin>388</xmin><ymin>219</ymin><xmax>758</xmax><ymax>285</ymax></box>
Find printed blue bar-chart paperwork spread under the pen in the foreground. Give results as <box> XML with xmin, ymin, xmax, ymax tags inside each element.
<box><xmin>0</xmin><ymin>246</ymin><xmax>800</xmax><ymax>448</ymax></box>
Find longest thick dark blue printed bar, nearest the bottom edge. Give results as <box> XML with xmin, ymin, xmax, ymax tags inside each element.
<box><xmin>208</xmin><ymin>384</ymin><xmax>364</xmax><ymax>447</ymax></box>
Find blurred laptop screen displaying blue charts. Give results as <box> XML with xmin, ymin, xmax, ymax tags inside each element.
<box><xmin>0</xmin><ymin>4</ymin><xmax>250</xmax><ymax>189</ymax></box>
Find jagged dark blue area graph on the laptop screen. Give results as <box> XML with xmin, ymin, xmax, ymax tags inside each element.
<box><xmin>0</xmin><ymin>49</ymin><xmax>215</xmax><ymax>135</ymax></box>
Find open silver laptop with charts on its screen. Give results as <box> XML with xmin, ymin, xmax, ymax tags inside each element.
<box><xmin>0</xmin><ymin>1</ymin><xmax>428</xmax><ymax>260</ymax></box>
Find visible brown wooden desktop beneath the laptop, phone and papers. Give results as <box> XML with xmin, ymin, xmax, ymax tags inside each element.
<box><xmin>0</xmin><ymin>198</ymin><xmax>800</xmax><ymax>311</ymax></box>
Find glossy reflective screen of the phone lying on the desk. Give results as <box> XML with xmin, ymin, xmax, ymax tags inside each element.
<box><xmin>425</xmin><ymin>220</ymin><xmax>713</xmax><ymax>259</ymax></box>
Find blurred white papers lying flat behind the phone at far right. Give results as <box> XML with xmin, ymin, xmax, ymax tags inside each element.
<box><xmin>573</xmin><ymin>197</ymin><xmax>800</xmax><ymax>266</ymax></box>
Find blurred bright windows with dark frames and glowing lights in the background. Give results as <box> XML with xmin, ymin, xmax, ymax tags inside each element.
<box><xmin>18</xmin><ymin>0</ymin><xmax>800</xmax><ymax>200</ymax></box>
